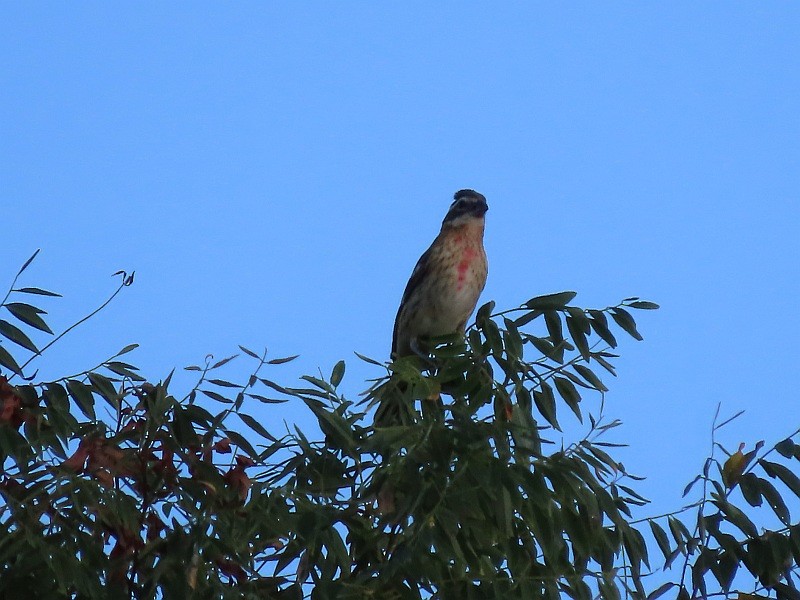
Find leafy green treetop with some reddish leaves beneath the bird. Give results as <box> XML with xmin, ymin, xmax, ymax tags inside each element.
<box><xmin>0</xmin><ymin>254</ymin><xmax>800</xmax><ymax>599</ymax></box>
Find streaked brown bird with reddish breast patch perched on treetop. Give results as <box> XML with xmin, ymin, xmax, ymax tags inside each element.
<box><xmin>392</xmin><ymin>190</ymin><xmax>489</xmax><ymax>358</ymax></box>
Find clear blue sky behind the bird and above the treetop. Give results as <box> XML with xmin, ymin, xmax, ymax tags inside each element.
<box><xmin>0</xmin><ymin>2</ymin><xmax>800</xmax><ymax>520</ymax></box>
